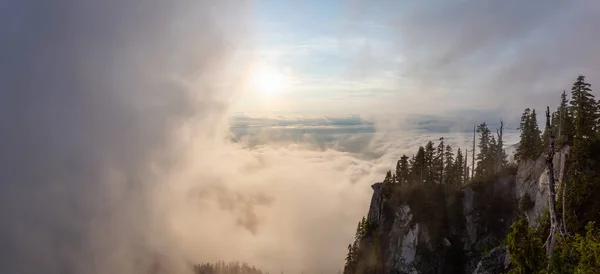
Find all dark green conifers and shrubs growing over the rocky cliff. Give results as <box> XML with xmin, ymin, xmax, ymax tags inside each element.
<box><xmin>344</xmin><ymin>76</ymin><xmax>600</xmax><ymax>273</ymax></box>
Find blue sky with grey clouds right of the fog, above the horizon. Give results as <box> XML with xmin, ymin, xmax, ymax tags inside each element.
<box><xmin>235</xmin><ymin>0</ymin><xmax>600</xmax><ymax>124</ymax></box>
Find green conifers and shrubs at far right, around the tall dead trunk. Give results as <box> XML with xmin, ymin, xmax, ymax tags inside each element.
<box><xmin>508</xmin><ymin>76</ymin><xmax>600</xmax><ymax>273</ymax></box>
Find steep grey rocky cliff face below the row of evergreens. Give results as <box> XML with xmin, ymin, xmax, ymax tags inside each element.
<box><xmin>356</xmin><ymin>147</ymin><xmax>570</xmax><ymax>274</ymax></box>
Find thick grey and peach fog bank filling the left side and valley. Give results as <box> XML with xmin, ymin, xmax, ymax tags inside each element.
<box><xmin>0</xmin><ymin>0</ymin><xmax>536</xmax><ymax>274</ymax></box>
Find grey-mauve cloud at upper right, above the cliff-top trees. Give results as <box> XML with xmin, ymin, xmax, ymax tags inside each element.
<box><xmin>338</xmin><ymin>0</ymin><xmax>600</xmax><ymax>119</ymax></box>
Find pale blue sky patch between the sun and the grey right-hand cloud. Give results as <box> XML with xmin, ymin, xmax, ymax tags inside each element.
<box><xmin>233</xmin><ymin>1</ymin><xmax>404</xmax><ymax>115</ymax></box>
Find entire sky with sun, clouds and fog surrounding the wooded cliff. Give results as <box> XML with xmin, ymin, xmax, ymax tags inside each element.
<box><xmin>0</xmin><ymin>0</ymin><xmax>600</xmax><ymax>274</ymax></box>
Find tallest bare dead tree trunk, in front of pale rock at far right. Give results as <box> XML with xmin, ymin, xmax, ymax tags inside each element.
<box><xmin>546</xmin><ymin>107</ymin><xmax>563</xmax><ymax>258</ymax></box>
